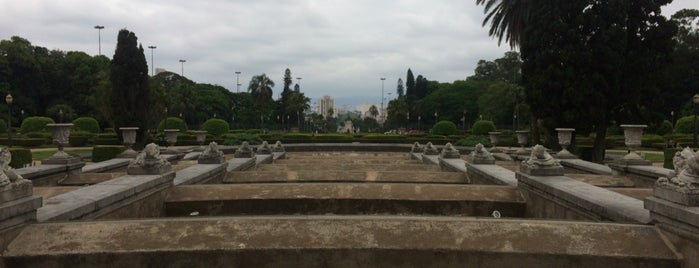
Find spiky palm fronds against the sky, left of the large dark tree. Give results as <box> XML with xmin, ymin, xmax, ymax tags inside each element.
<box><xmin>476</xmin><ymin>0</ymin><xmax>535</xmax><ymax>48</ymax></box>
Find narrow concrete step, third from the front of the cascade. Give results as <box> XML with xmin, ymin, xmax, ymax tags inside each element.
<box><xmin>222</xmin><ymin>170</ymin><xmax>469</xmax><ymax>184</ymax></box>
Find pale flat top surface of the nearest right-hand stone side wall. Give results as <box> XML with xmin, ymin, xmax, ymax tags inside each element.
<box><xmin>516</xmin><ymin>172</ymin><xmax>650</xmax><ymax>224</ymax></box>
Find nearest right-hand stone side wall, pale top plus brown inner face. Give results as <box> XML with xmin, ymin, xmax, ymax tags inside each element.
<box><xmin>517</xmin><ymin>172</ymin><xmax>650</xmax><ymax>224</ymax></box>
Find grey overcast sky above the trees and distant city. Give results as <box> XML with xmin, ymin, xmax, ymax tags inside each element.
<box><xmin>0</xmin><ymin>0</ymin><xmax>699</xmax><ymax>106</ymax></box>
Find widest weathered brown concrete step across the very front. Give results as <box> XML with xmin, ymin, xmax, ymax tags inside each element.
<box><xmin>3</xmin><ymin>216</ymin><xmax>680</xmax><ymax>267</ymax></box>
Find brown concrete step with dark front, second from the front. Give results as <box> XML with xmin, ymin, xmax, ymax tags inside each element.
<box><xmin>165</xmin><ymin>183</ymin><xmax>525</xmax><ymax>217</ymax></box>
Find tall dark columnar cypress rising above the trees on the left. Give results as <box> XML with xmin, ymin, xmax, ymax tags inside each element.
<box><xmin>109</xmin><ymin>29</ymin><xmax>153</xmax><ymax>143</ymax></box>
